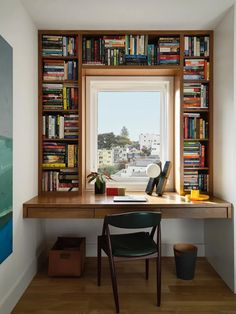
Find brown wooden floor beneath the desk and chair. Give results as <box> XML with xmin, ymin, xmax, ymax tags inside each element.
<box><xmin>12</xmin><ymin>258</ymin><xmax>236</xmax><ymax>314</ymax></box>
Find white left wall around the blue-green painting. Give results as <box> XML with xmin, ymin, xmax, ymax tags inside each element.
<box><xmin>0</xmin><ymin>0</ymin><xmax>43</xmax><ymax>314</ymax></box>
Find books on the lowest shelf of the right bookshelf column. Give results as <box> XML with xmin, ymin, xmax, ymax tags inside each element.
<box><xmin>184</xmin><ymin>170</ymin><xmax>209</xmax><ymax>192</ymax></box>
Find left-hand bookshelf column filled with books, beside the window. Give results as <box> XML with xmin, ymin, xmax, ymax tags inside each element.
<box><xmin>39</xmin><ymin>31</ymin><xmax>81</xmax><ymax>194</ymax></box>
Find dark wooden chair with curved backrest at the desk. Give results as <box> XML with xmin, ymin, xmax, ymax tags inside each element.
<box><xmin>97</xmin><ymin>212</ymin><xmax>161</xmax><ymax>313</ymax></box>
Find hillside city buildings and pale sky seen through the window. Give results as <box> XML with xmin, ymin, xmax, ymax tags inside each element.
<box><xmin>97</xmin><ymin>91</ymin><xmax>162</xmax><ymax>183</ymax></box>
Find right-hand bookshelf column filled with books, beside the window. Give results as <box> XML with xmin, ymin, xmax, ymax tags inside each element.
<box><xmin>182</xmin><ymin>32</ymin><xmax>213</xmax><ymax>194</ymax></box>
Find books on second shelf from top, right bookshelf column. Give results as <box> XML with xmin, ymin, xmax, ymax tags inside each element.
<box><xmin>184</xmin><ymin>59</ymin><xmax>209</xmax><ymax>80</ymax></box>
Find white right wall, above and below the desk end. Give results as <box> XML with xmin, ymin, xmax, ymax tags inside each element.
<box><xmin>205</xmin><ymin>7</ymin><xmax>236</xmax><ymax>292</ymax></box>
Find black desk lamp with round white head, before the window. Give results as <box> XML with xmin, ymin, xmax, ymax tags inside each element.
<box><xmin>145</xmin><ymin>161</ymin><xmax>171</xmax><ymax>196</ymax></box>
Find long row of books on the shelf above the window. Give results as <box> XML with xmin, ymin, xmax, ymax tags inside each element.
<box><xmin>82</xmin><ymin>35</ymin><xmax>180</xmax><ymax>65</ymax></box>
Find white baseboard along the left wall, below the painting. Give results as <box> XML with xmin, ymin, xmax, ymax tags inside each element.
<box><xmin>0</xmin><ymin>252</ymin><xmax>45</xmax><ymax>314</ymax></box>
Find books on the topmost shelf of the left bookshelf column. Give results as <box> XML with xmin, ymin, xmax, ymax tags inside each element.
<box><xmin>42</xmin><ymin>35</ymin><xmax>78</xmax><ymax>57</ymax></box>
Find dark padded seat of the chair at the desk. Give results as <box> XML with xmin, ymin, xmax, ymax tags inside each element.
<box><xmin>98</xmin><ymin>232</ymin><xmax>157</xmax><ymax>257</ymax></box>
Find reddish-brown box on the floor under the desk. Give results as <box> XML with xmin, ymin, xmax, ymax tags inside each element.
<box><xmin>48</xmin><ymin>237</ymin><xmax>85</xmax><ymax>277</ymax></box>
